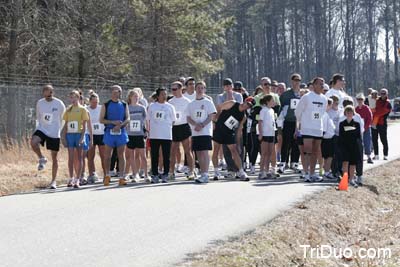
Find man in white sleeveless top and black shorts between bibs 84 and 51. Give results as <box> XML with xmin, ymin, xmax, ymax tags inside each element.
<box><xmin>168</xmin><ymin>81</ymin><xmax>195</xmax><ymax>180</ymax></box>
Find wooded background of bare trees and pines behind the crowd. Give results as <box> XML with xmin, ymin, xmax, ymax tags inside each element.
<box><xmin>0</xmin><ymin>0</ymin><xmax>400</xmax><ymax>141</ymax></box>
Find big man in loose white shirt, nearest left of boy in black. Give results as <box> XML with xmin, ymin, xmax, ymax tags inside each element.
<box><xmin>295</xmin><ymin>77</ymin><xmax>328</xmax><ymax>182</ymax></box>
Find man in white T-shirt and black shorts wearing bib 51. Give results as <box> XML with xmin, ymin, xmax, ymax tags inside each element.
<box><xmin>186</xmin><ymin>82</ymin><xmax>217</xmax><ymax>183</ymax></box>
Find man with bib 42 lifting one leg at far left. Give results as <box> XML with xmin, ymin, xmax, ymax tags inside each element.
<box><xmin>31</xmin><ymin>84</ymin><xmax>65</xmax><ymax>189</ymax></box>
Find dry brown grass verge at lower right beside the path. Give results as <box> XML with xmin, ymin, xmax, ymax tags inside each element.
<box><xmin>180</xmin><ymin>161</ymin><xmax>400</xmax><ymax>267</ymax></box>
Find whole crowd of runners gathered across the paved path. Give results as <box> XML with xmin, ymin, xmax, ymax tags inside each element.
<box><xmin>31</xmin><ymin>73</ymin><xmax>391</xmax><ymax>189</ymax></box>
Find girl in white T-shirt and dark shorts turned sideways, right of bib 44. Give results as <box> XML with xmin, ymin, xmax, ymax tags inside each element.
<box><xmin>258</xmin><ymin>95</ymin><xmax>276</xmax><ymax>179</ymax></box>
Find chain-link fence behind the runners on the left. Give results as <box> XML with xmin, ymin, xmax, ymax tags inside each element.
<box><xmin>0</xmin><ymin>76</ymin><xmax>221</xmax><ymax>143</ymax></box>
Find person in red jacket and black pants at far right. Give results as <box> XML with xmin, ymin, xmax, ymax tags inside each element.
<box><xmin>372</xmin><ymin>88</ymin><xmax>392</xmax><ymax>160</ymax></box>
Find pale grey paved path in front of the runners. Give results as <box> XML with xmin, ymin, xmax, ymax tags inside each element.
<box><xmin>0</xmin><ymin>124</ymin><xmax>400</xmax><ymax>267</ymax></box>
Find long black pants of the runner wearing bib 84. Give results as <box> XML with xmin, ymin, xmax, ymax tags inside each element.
<box><xmin>150</xmin><ymin>139</ymin><xmax>172</xmax><ymax>175</ymax></box>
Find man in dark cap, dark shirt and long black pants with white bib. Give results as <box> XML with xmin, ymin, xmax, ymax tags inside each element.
<box><xmin>278</xmin><ymin>73</ymin><xmax>301</xmax><ymax>173</ymax></box>
